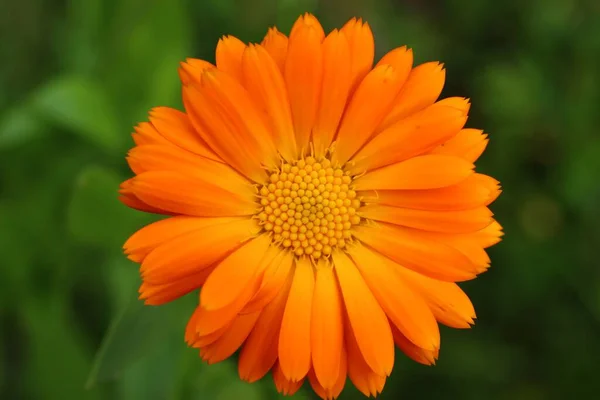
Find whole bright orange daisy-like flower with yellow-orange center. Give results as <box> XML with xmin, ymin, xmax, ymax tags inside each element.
<box><xmin>121</xmin><ymin>14</ymin><xmax>502</xmax><ymax>398</ymax></box>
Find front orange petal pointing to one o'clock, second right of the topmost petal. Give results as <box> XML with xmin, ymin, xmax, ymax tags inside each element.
<box><xmin>332</xmin><ymin>65</ymin><xmax>402</xmax><ymax>165</ymax></box>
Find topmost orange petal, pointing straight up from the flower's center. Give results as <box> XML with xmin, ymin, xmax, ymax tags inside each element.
<box><xmin>283</xmin><ymin>15</ymin><xmax>323</xmax><ymax>152</ymax></box>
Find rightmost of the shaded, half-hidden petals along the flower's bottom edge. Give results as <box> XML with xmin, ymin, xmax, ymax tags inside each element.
<box><xmin>344</xmin><ymin>321</ymin><xmax>389</xmax><ymax>397</ymax></box>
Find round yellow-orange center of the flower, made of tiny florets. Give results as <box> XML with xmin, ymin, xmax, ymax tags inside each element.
<box><xmin>258</xmin><ymin>157</ymin><xmax>360</xmax><ymax>259</ymax></box>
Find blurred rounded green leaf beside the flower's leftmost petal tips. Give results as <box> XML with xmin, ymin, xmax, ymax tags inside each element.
<box><xmin>68</xmin><ymin>166</ymin><xmax>152</xmax><ymax>248</ymax></box>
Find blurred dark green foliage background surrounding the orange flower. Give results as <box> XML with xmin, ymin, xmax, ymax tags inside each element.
<box><xmin>0</xmin><ymin>0</ymin><xmax>600</xmax><ymax>400</ymax></box>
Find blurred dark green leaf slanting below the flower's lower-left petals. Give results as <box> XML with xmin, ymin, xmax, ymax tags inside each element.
<box><xmin>86</xmin><ymin>299</ymin><xmax>186</xmax><ymax>388</ymax></box>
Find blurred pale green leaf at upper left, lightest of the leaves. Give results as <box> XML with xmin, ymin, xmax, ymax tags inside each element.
<box><xmin>34</xmin><ymin>75</ymin><xmax>127</xmax><ymax>152</ymax></box>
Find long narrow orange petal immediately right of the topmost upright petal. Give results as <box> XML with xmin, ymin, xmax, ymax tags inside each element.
<box><xmin>312</xmin><ymin>29</ymin><xmax>352</xmax><ymax>158</ymax></box>
